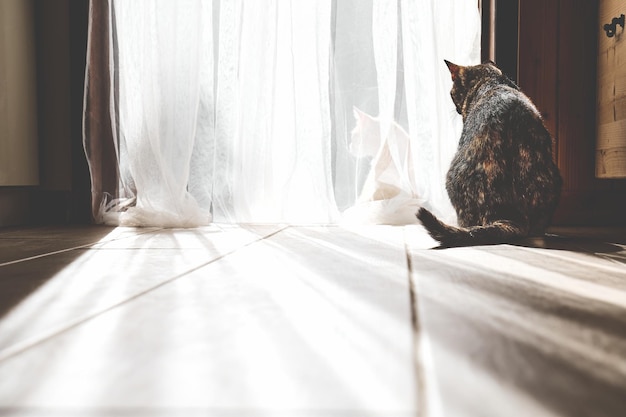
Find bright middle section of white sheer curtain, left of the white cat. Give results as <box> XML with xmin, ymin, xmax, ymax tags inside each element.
<box><xmin>213</xmin><ymin>1</ymin><xmax>336</xmax><ymax>223</ymax></box>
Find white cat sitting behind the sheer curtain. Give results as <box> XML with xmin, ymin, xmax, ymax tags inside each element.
<box><xmin>343</xmin><ymin>107</ymin><xmax>421</xmax><ymax>224</ymax></box>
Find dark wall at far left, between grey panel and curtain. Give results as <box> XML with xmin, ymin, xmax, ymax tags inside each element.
<box><xmin>0</xmin><ymin>0</ymin><xmax>91</xmax><ymax>226</ymax></box>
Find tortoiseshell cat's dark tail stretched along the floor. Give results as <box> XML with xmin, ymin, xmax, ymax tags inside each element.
<box><xmin>417</xmin><ymin>207</ymin><xmax>528</xmax><ymax>248</ymax></box>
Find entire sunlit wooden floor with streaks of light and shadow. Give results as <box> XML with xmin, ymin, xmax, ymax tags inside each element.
<box><xmin>0</xmin><ymin>225</ymin><xmax>626</xmax><ymax>417</ymax></box>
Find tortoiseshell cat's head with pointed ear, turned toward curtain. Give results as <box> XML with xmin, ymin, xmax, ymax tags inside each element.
<box><xmin>444</xmin><ymin>60</ymin><xmax>515</xmax><ymax>115</ymax></box>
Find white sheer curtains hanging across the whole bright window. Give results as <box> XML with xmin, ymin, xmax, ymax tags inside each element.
<box><xmin>85</xmin><ymin>0</ymin><xmax>480</xmax><ymax>227</ymax></box>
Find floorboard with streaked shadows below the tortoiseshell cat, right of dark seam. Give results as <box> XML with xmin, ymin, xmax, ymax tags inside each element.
<box><xmin>410</xmin><ymin>226</ymin><xmax>626</xmax><ymax>416</ymax></box>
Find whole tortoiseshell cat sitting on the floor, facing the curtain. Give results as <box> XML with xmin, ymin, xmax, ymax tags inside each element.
<box><xmin>417</xmin><ymin>61</ymin><xmax>562</xmax><ymax>247</ymax></box>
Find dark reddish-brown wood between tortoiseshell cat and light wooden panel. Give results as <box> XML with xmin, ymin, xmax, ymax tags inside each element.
<box><xmin>518</xmin><ymin>0</ymin><xmax>626</xmax><ymax>225</ymax></box>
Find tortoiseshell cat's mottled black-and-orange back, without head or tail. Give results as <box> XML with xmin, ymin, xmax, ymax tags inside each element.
<box><xmin>451</xmin><ymin>77</ymin><xmax>562</xmax><ymax>228</ymax></box>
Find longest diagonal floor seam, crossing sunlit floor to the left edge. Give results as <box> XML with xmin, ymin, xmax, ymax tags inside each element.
<box><xmin>0</xmin><ymin>226</ymin><xmax>290</xmax><ymax>363</ymax></box>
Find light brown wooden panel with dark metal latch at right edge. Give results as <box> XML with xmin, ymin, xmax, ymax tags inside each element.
<box><xmin>596</xmin><ymin>0</ymin><xmax>626</xmax><ymax>178</ymax></box>
